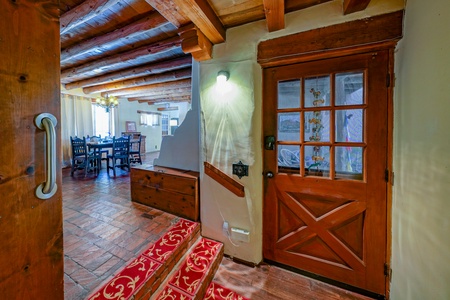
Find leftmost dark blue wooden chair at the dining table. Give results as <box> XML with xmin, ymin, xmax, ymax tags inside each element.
<box><xmin>70</xmin><ymin>137</ymin><xmax>101</xmax><ymax>176</ymax></box>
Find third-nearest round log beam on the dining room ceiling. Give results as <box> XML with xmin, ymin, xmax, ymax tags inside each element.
<box><xmin>61</xmin><ymin>36</ymin><xmax>181</xmax><ymax>82</ymax></box>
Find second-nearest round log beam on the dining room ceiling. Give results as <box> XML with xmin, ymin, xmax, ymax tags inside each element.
<box><xmin>61</xmin><ymin>11</ymin><xmax>168</xmax><ymax>61</ymax></box>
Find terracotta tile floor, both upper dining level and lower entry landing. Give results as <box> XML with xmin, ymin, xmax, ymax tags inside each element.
<box><xmin>62</xmin><ymin>153</ymin><xmax>370</xmax><ymax>300</ymax></box>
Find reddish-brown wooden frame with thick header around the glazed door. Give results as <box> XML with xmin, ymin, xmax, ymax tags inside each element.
<box><xmin>258</xmin><ymin>10</ymin><xmax>404</xmax><ymax>299</ymax></box>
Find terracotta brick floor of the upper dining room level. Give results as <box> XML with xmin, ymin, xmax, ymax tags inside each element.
<box><xmin>62</xmin><ymin>155</ymin><xmax>177</xmax><ymax>300</ymax></box>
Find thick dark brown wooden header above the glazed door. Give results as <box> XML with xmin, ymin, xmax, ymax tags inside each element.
<box><xmin>258</xmin><ymin>10</ymin><xmax>404</xmax><ymax>67</ymax></box>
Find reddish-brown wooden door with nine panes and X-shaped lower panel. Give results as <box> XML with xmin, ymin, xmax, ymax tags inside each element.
<box><xmin>263</xmin><ymin>50</ymin><xmax>389</xmax><ymax>294</ymax></box>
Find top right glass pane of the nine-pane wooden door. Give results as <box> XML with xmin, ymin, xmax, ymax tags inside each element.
<box><xmin>335</xmin><ymin>72</ymin><xmax>364</xmax><ymax>105</ymax></box>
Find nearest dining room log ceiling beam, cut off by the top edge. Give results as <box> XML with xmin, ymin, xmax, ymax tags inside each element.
<box><xmin>60</xmin><ymin>0</ymin><xmax>121</xmax><ymax>35</ymax></box>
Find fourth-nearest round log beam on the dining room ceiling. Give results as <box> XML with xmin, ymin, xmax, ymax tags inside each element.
<box><xmin>64</xmin><ymin>55</ymin><xmax>192</xmax><ymax>90</ymax></box>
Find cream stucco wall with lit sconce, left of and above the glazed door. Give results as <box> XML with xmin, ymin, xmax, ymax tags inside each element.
<box><xmin>200</xmin><ymin>0</ymin><xmax>404</xmax><ymax>263</ymax></box>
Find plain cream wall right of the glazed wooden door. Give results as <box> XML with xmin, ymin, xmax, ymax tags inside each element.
<box><xmin>391</xmin><ymin>0</ymin><xmax>450</xmax><ymax>300</ymax></box>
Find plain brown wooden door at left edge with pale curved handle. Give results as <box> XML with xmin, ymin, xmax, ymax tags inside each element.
<box><xmin>0</xmin><ymin>0</ymin><xmax>64</xmax><ymax>299</ymax></box>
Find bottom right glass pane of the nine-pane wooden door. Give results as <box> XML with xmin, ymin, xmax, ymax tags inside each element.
<box><xmin>335</xmin><ymin>147</ymin><xmax>364</xmax><ymax>180</ymax></box>
